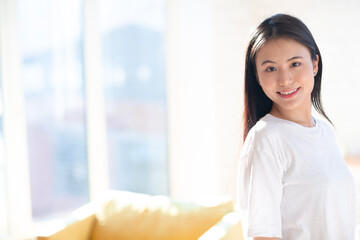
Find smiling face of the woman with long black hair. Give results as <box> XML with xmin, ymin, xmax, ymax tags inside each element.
<box><xmin>255</xmin><ymin>38</ymin><xmax>318</xmax><ymax>114</ymax></box>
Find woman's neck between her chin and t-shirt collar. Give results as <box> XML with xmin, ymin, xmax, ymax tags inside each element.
<box><xmin>270</xmin><ymin>104</ymin><xmax>313</xmax><ymax>127</ymax></box>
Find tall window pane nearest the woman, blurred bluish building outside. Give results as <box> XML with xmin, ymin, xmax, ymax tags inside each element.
<box><xmin>98</xmin><ymin>0</ymin><xmax>169</xmax><ymax>194</ymax></box>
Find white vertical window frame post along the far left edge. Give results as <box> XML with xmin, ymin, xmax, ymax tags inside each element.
<box><xmin>0</xmin><ymin>0</ymin><xmax>32</xmax><ymax>237</ymax></box>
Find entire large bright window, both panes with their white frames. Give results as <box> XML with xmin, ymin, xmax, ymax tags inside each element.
<box><xmin>0</xmin><ymin>0</ymin><xmax>169</xmax><ymax>236</ymax></box>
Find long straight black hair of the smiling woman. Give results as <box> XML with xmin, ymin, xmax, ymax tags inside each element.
<box><xmin>243</xmin><ymin>14</ymin><xmax>331</xmax><ymax>141</ymax></box>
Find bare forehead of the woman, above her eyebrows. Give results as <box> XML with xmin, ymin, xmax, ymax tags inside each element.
<box><xmin>255</xmin><ymin>38</ymin><xmax>311</xmax><ymax>64</ymax></box>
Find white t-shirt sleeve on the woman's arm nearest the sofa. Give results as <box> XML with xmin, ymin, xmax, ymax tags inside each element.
<box><xmin>239</xmin><ymin>141</ymin><xmax>284</xmax><ymax>238</ymax></box>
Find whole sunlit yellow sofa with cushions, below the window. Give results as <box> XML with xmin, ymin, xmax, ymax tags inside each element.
<box><xmin>37</xmin><ymin>191</ymin><xmax>243</xmax><ymax>240</ymax></box>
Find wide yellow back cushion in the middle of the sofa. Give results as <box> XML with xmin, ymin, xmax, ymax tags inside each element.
<box><xmin>92</xmin><ymin>192</ymin><xmax>233</xmax><ymax>240</ymax></box>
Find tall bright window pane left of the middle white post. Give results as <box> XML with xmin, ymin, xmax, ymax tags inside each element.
<box><xmin>17</xmin><ymin>0</ymin><xmax>89</xmax><ymax>219</ymax></box>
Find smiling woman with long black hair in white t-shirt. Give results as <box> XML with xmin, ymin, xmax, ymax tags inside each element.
<box><xmin>239</xmin><ymin>14</ymin><xmax>355</xmax><ymax>240</ymax></box>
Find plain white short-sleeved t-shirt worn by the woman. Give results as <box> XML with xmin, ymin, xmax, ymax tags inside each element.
<box><xmin>239</xmin><ymin>114</ymin><xmax>355</xmax><ymax>240</ymax></box>
